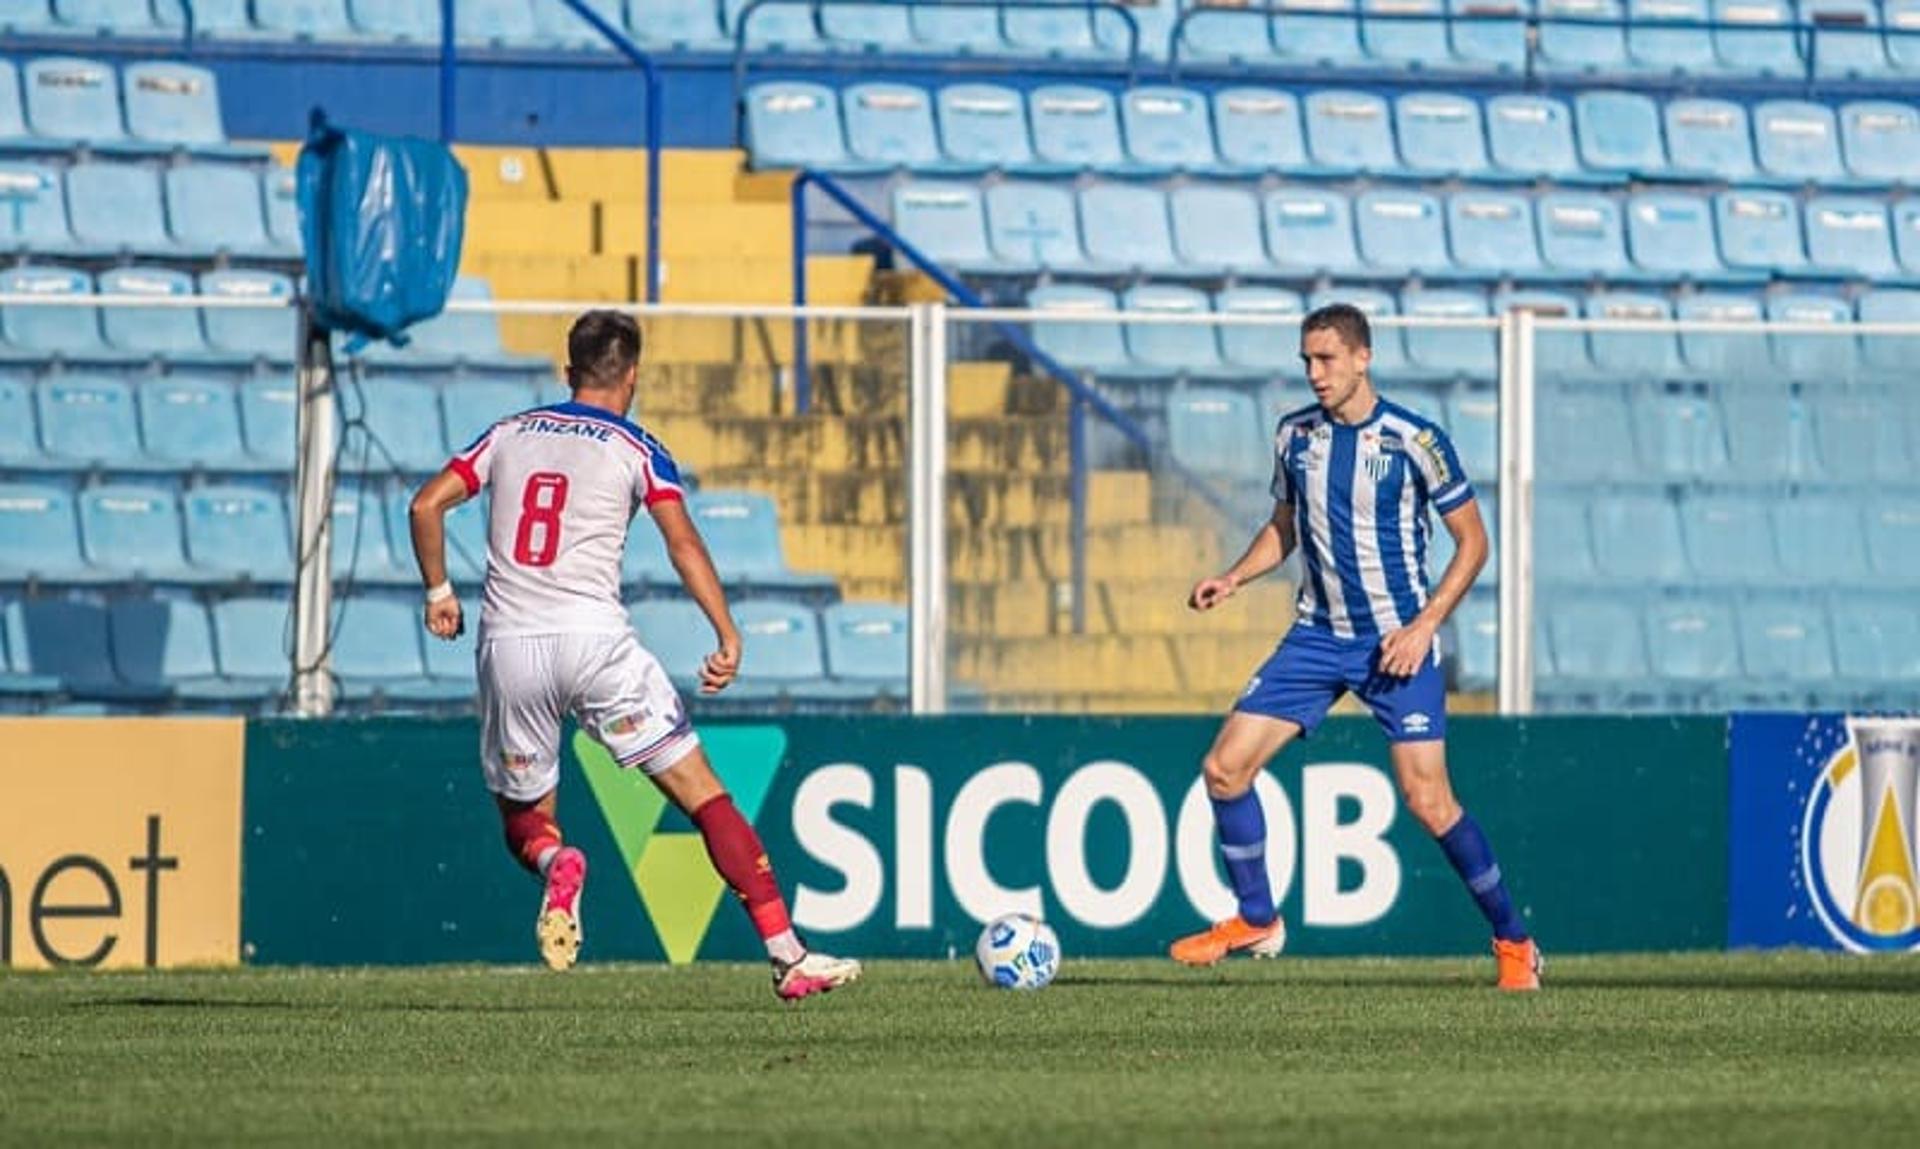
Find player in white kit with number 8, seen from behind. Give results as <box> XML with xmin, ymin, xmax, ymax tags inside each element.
<box><xmin>411</xmin><ymin>311</ymin><xmax>860</xmax><ymax>1001</ymax></box>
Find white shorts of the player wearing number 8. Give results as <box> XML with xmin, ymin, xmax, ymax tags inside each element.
<box><xmin>478</xmin><ymin>630</ymin><xmax>701</xmax><ymax>801</ymax></box>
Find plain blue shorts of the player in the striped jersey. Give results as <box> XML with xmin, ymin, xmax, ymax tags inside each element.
<box><xmin>1233</xmin><ymin>624</ymin><xmax>1446</xmax><ymax>742</ymax></box>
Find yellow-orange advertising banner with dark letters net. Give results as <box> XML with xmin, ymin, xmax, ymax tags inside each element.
<box><xmin>0</xmin><ymin>719</ymin><xmax>246</xmax><ymax>968</ymax></box>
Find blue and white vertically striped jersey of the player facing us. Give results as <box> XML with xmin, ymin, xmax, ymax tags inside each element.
<box><xmin>1273</xmin><ymin>400</ymin><xmax>1473</xmax><ymax>638</ymax></box>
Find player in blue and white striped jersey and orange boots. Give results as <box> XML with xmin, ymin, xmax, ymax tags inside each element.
<box><xmin>1171</xmin><ymin>304</ymin><xmax>1540</xmax><ymax>990</ymax></box>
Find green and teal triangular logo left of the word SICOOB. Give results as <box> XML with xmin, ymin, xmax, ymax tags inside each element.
<box><xmin>572</xmin><ymin>726</ymin><xmax>787</xmax><ymax>965</ymax></box>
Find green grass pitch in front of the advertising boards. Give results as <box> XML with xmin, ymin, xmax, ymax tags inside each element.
<box><xmin>0</xmin><ymin>955</ymin><xmax>1920</xmax><ymax>1149</ymax></box>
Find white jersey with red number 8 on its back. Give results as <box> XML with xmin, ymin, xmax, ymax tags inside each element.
<box><xmin>447</xmin><ymin>403</ymin><xmax>685</xmax><ymax>638</ymax></box>
